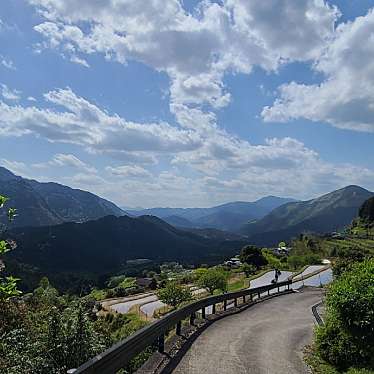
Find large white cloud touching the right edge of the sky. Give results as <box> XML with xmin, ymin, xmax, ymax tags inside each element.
<box><xmin>262</xmin><ymin>10</ymin><xmax>374</xmax><ymax>132</ymax></box>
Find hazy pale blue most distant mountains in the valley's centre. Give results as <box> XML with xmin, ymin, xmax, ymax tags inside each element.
<box><xmin>127</xmin><ymin>196</ymin><xmax>295</xmax><ymax>232</ymax></box>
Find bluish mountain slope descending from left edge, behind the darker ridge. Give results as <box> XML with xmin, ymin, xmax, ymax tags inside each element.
<box><xmin>0</xmin><ymin>167</ymin><xmax>124</xmax><ymax>227</ymax></box>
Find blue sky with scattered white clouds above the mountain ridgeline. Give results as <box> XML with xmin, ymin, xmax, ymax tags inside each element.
<box><xmin>0</xmin><ymin>0</ymin><xmax>374</xmax><ymax>207</ymax></box>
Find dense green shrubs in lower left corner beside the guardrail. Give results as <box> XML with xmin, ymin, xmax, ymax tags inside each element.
<box><xmin>0</xmin><ymin>278</ymin><xmax>111</xmax><ymax>374</ymax></box>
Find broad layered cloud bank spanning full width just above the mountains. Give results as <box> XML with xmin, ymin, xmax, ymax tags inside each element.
<box><xmin>0</xmin><ymin>84</ymin><xmax>374</xmax><ymax>206</ymax></box>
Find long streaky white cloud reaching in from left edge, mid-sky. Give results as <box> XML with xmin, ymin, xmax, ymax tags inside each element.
<box><xmin>0</xmin><ymin>88</ymin><xmax>201</xmax><ymax>154</ymax></box>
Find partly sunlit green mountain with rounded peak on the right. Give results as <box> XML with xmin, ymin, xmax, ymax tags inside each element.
<box><xmin>241</xmin><ymin>186</ymin><xmax>374</xmax><ymax>245</ymax></box>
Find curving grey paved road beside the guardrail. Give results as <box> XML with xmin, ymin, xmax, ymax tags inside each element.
<box><xmin>173</xmin><ymin>289</ymin><xmax>321</xmax><ymax>374</ymax></box>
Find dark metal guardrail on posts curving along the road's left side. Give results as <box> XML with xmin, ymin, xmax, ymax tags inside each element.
<box><xmin>71</xmin><ymin>280</ymin><xmax>292</xmax><ymax>374</ymax></box>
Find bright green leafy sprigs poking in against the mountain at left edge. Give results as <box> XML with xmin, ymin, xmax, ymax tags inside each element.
<box><xmin>0</xmin><ymin>195</ymin><xmax>21</xmax><ymax>301</ymax></box>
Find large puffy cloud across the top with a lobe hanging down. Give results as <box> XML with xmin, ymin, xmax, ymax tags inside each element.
<box><xmin>29</xmin><ymin>0</ymin><xmax>339</xmax><ymax>127</ymax></box>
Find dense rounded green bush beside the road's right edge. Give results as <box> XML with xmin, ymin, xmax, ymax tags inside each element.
<box><xmin>316</xmin><ymin>259</ymin><xmax>374</xmax><ymax>369</ymax></box>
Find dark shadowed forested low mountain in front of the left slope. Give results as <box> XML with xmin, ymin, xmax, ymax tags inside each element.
<box><xmin>5</xmin><ymin>216</ymin><xmax>245</xmax><ymax>289</ymax></box>
